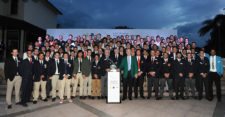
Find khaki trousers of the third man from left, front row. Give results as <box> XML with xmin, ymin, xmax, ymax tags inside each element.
<box><xmin>33</xmin><ymin>80</ymin><xmax>47</xmax><ymax>101</ymax></box>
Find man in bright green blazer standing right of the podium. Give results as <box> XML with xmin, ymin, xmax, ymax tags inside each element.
<box><xmin>120</xmin><ymin>48</ymin><xmax>138</xmax><ymax>100</ymax></box>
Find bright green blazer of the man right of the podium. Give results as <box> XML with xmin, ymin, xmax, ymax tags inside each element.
<box><xmin>120</xmin><ymin>56</ymin><xmax>138</xmax><ymax>78</ymax></box>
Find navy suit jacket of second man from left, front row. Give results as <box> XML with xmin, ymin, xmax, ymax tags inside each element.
<box><xmin>19</xmin><ymin>58</ymin><xmax>35</xmax><ymax>80</ymax></box>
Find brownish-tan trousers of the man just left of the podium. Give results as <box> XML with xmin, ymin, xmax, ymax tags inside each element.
<box><xmin>92</xmin><ymin>79</ymin><xmax>101</xmax><ymax>96</ymax></box>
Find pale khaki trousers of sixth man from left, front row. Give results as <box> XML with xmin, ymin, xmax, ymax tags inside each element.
<box><xmin>72</xmin><ymin>73</ymin><xmax>84</xmax><ymax>96</ymax></box>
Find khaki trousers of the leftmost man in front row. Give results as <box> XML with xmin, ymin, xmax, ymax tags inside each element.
<box><xmin>6</xmin><ymin>76</ymin><xmax>22</xmax><ymax>105</ymax></box>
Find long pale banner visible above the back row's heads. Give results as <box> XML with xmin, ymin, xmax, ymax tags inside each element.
<box><xmin>47</xmin><ymin>29</ymin><xmax>177</xmax><ymax>40</ymax></box>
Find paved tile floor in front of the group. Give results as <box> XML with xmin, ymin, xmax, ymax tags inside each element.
<box><xmin>0</xmin><ymin>99</ymin><xmax>220</xmax><ymax>117</ymax></box>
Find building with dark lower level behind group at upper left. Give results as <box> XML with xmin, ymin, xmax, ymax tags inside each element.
<box><xmin>0</xmin><ymin>0</ymin><xmax>62</xmax><ymax>61</ymax></box>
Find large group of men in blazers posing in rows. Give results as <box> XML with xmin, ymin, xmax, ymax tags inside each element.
<box><xmin>4</xmin><ymin>35</ymin><xmax>223</xmax><ymax>109</ymax></box>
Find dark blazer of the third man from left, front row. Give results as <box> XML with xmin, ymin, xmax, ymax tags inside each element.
<box><xmin>34</xmin><ymin>61</ymin><xmax>47</xmax><ymax>82</ymax></box>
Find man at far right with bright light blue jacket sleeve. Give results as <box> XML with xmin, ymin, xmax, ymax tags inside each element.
<box><xmin>209</xmin><ymin>49</ymin><xmax>223</xmax><ymax>102</ymax></box>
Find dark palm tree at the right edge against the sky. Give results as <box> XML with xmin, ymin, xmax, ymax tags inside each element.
<box><xmin>198</xmin><ymin>14</ymin><xmax>225</xmax><ymax>57</ymax></box>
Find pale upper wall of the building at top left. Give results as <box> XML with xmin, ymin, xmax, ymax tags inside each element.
<box><xmin>24</xmin><ymin>0</ymin><xmax>57</xmax><ymax>29</ymax></box>
